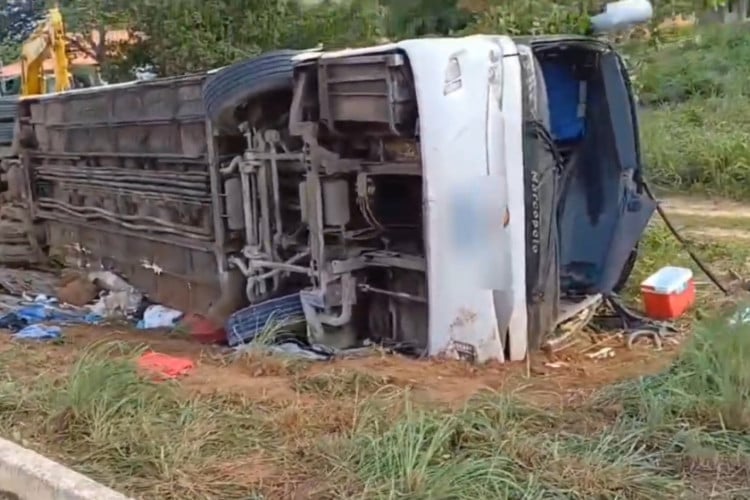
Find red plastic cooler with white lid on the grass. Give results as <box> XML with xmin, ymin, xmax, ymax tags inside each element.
<box><xmin>641</xmin><ymin>266</ymin><xmax>695</xmax><ymax>320</ymax></box>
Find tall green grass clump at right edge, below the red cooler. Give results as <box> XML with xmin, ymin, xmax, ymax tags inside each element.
<box><xmin>594</xmin><ymin>312</ymin><xmax>750</xmax><ymax>498</ymax></box>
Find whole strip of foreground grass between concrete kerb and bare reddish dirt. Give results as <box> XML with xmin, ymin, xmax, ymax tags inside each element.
<box><xmin>0</xmin><ymin>310</ymin><xmax>750</xmax><ymax>500</ymax></box>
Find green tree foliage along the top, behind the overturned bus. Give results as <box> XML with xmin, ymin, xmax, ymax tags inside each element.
<box><xmin>63</xmin><ymin>0</ymin><xmax>604</xmax><ymax>76</ymax></box>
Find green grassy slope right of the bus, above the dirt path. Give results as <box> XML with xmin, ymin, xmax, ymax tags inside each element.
<box><xmin>629</xmin><ymin>25</ymin><xmax>750</xmax><ymax>200</ymax></box>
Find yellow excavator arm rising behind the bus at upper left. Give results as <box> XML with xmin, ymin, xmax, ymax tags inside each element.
<box><xmin>21</xmin><ymin>8</ymin><xmax>71</xmax><ymax>96</ymax></box>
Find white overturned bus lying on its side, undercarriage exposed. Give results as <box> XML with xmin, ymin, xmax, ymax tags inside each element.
<box><xmin>10</xmin><ymin>2</ymin><xmax>655</xmax><ymax>361</ymax></box>
